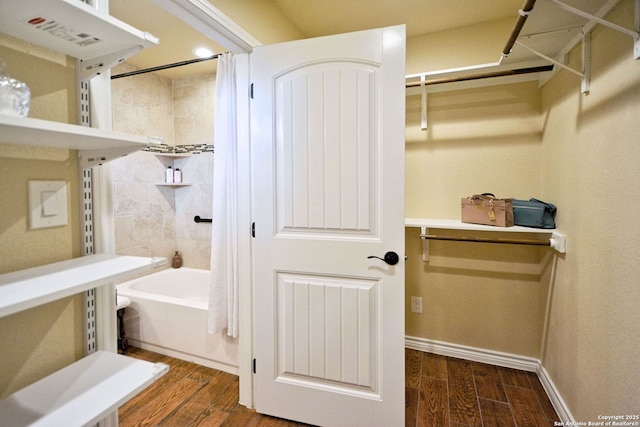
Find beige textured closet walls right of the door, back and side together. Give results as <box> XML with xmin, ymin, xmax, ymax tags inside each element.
<box><xmin>406</xmin><ymin>0</ymin><xmax>640</xmax><ymax>422</ymax></box>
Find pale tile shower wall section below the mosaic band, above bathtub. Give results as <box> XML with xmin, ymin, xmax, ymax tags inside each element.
<box><xmin>112</xmin><ymin>152</ymin><xmax>213</xmax><ymax>269</ymax></box>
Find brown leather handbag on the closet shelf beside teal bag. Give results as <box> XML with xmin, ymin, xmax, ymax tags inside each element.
<box><xmin>460</xmin><ymin>193</ymin><xmax>513</xmax><ymax>227</ymax></box>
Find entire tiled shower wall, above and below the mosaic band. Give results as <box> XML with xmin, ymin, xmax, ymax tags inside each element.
<box><xmin>110</xmin><ymin>63</ymin><xmax>215</xmax><ymax>269</ymax></box>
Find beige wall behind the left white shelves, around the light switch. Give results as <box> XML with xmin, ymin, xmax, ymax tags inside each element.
<box><xmin>0</xmin><ymin>34</ymin><xmax>84</xmax><ymax>397</ymax></box>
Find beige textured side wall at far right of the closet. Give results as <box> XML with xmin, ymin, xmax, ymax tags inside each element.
<box><xmin>542</xmin><ymin>0</ymin><xmax>640</xmax><ymax>422</ymax></box>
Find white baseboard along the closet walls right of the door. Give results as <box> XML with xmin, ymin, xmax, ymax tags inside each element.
<box><xmin>405</xmin><ymin>336</ymin><xmax>575</xmax><ymax>424</ymax></box>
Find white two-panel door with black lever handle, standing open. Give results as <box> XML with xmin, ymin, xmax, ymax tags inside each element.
<box><xmin>251</xmin><ymin>26</ymin><xmax>405</xmax><ymax>427</ymax></box>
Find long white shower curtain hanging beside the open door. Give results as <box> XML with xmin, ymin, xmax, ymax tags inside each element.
<box><xmin>208</xmin><ymin>53</ymin><xmax>238</xmax><ymax>338</ymax></box>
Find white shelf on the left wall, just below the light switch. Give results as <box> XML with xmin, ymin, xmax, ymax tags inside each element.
<box><xmin>0</xmin><ymin>255</ymin><xmax>166</xmax><ymax>317</ymax></box>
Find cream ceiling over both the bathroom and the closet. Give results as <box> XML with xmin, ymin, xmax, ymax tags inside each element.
<box><xmin>110</xmin><ymin>0</ymin><xmax>524</xmax><ymax>78</ymax></box>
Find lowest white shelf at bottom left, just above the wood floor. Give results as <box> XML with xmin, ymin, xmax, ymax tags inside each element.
<box><xmin>0</xmin><ymin>351</ymin><xmax>169</xmax><ymax>427</ymax></box>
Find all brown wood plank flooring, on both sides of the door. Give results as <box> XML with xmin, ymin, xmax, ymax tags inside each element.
<box><xmin>119</xmin><ymin>348</ymin><xmax>558</xmax><ymax>427</ymax></box>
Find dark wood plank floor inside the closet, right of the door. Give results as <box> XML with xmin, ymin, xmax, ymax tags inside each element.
<box><xmin>405</xmin><ymin>349</ymin><xmax>559</xmax><ymax>427</ymax></box>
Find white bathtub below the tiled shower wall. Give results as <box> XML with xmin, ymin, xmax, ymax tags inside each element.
<box><xmin>116</xmin><ymin>267</ymin><xmax>238</xmax><ymax>375</ymax></box>
